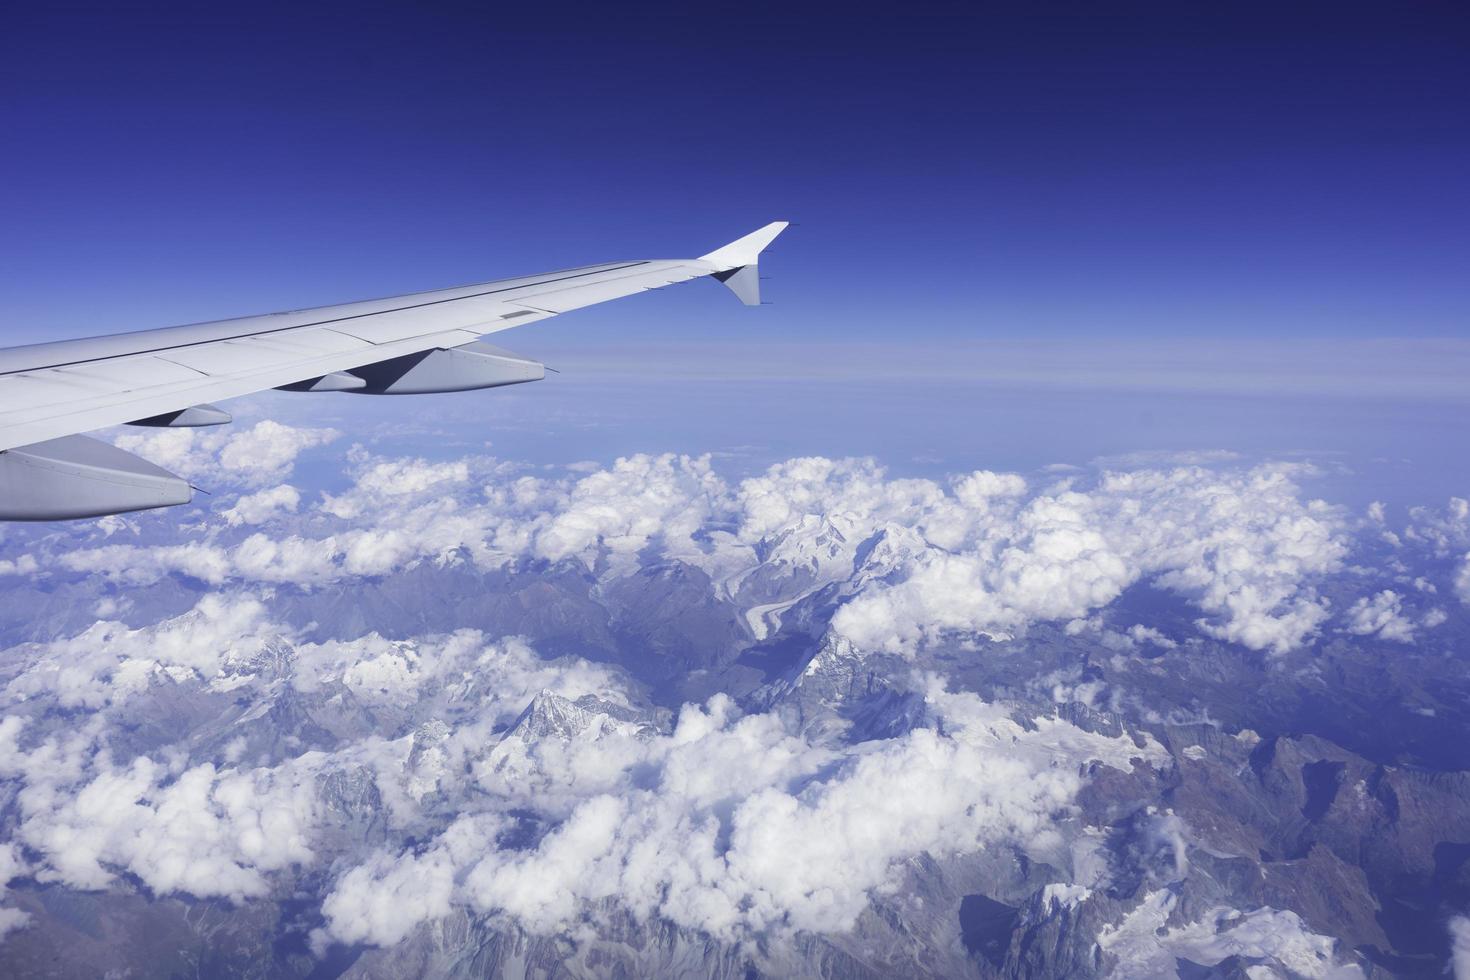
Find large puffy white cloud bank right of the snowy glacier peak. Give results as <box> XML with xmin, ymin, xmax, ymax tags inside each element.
<box><xmin>832</xmin><ymin>466</ymin><xmax>1348</xmax><ymax>652</ymax></box>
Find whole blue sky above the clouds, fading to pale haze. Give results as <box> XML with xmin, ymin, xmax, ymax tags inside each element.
<box><xmin>0</xmin><ymin>3</ymin><xmax>1470</xmax><ymax>505</ymax></box>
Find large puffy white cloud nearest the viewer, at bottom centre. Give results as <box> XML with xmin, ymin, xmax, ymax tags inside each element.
<box><xmin>319</xmin><ymin>686</ymin><xmax>1163</xmax><ymax>945</ymax></box>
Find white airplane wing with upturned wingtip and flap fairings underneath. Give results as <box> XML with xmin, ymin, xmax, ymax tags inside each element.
<box><xmin>0</xmin><ymin>222</ymin><xmax>786</xmax><ymax>520</ymax></box>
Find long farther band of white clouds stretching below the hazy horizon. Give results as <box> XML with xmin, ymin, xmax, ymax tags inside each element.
<box><xmin>48</xmin><ymin>455</ymin><xmax>1352</xmax><ymax>652</ymax></box>
